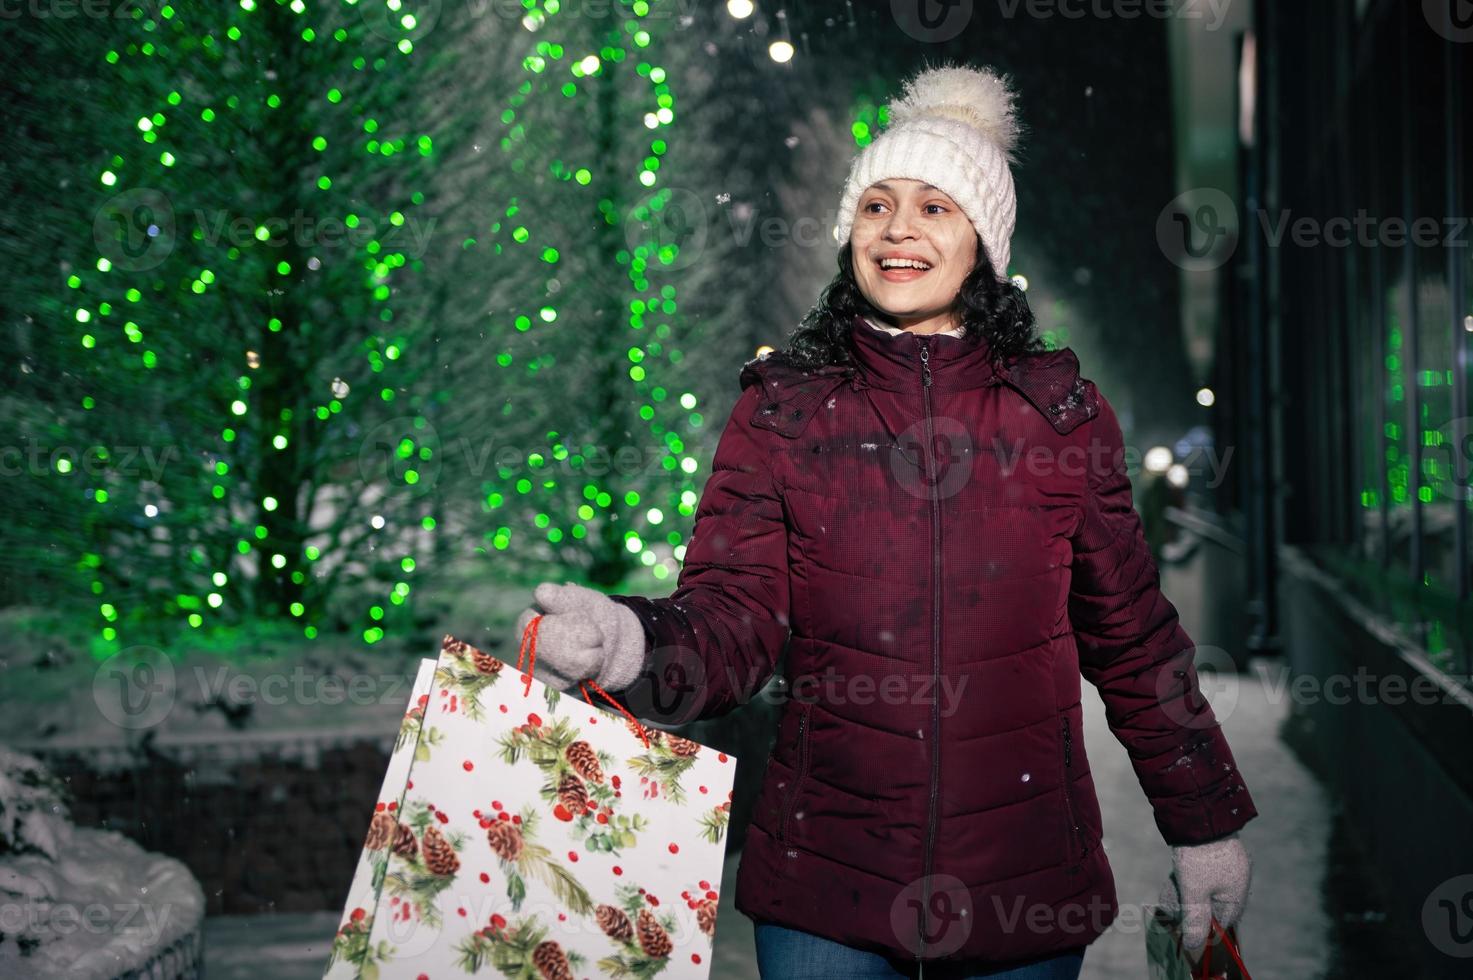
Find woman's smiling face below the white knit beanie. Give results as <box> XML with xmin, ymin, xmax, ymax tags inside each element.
<box><xmin>850</xmin><ymin>178</ymin><xmax>977</xmax><ymax>333</ymax></box>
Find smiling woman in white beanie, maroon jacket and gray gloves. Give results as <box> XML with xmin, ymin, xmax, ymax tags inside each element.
<box><xmin>517</xmin><ymin>68</ymin><xmax>1255</xmax><ymax>980</ymax></box>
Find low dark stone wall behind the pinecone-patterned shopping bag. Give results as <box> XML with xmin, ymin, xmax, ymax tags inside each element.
<box><xmin>15</xmin><ymin>686</ymin><xmax>776</xmax><ymax>915</ymax></box>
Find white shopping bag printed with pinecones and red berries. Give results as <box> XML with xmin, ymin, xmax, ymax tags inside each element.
<box><xmin>327</xmin><ymin>637</ymin><xmax>737</xmax><ymax>980</ymax></box>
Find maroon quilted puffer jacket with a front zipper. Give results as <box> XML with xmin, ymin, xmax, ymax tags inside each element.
<box><xmin>613</xmin><ymin>310</ymin><xmax>1256</xmax><ymax>961</ymax></box>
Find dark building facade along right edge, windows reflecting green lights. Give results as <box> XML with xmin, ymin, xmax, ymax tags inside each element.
<box><xmin>1218</xmin><ymin>0</ymin><xmax>1473</xmax><ymax>977</ymax></box>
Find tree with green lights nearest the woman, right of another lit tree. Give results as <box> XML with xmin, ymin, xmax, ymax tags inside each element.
<box><xmin>441</xmin><ymin>1</ymin><xmax>748</xmax><ymax>587</ymax></box>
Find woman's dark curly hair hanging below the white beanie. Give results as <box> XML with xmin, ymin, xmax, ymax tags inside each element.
<box><xmin>782</xmin><ymin>239</ymin><xmax>1047</xmax><ymax>370</ymax></box>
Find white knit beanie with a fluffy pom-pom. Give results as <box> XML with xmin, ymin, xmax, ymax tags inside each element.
<box><xmin>834</xmin><ymin>66</ymin><xmax>1022</xmax><ymax>279</ymax></box>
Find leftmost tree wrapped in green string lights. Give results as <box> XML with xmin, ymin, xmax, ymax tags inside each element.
<box><xmin>52</xmin><ymin>0</ymin><xmax>515</xmax><ymax>648</ymax></box>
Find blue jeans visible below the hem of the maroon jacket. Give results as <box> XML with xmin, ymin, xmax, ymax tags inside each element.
<box><xmin>756</xmin><ymin>921</ymin><xmax>1084</xmax><ymax>980</ymax></box>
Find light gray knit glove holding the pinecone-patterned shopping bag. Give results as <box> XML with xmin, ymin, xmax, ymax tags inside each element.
<box><xmin>514</xmin><ymin>582</ymin><xmax>645</xmax><ymax>694</ymax></box>
